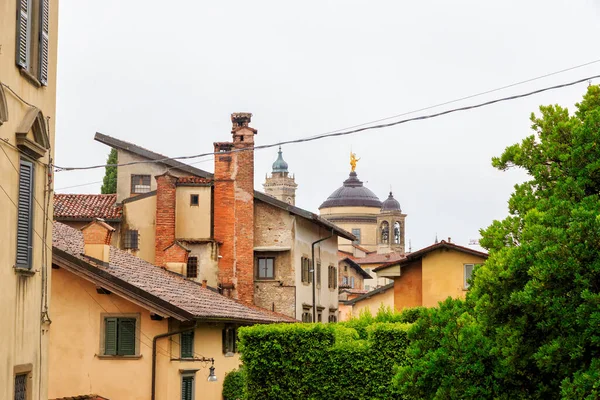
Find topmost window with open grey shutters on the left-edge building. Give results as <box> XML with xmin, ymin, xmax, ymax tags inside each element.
<box><xmin>15</xmin><ymin>0</ymin><xmax>50</xmax><ymax>85</ymax></box>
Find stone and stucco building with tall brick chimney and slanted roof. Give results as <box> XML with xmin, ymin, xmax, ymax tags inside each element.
<box><xmin>74</xmin><ymin>113</ymin><xmax>354</xmax><ymax>322</ymax></box>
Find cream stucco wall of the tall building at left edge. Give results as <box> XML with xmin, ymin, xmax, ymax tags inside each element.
<box><xmin>0</xmin><ymin>1</ymin><xmax>58</xmax><ymax>399</ymax></box>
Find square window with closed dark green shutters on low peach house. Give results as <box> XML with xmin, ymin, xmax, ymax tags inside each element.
<box><xmin>104</xmin><ymin>317</ymin><xmax>137</xmax><ymax>356</ymax></box>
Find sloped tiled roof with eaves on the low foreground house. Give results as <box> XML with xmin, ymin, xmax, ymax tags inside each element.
<box><xmin>52</xmin><ymin>222</ymin><xmax>295</xmax><ymax>323</ymax></box>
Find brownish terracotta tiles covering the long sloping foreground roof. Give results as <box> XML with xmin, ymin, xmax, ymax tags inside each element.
<box><xmin>52</xmin><ymin>222</ymin><xmax>296</xmax><ymax>323</ymax></box>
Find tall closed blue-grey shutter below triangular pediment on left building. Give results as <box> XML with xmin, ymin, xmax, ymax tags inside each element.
<box><xmin>16</xmin><ymin>160</ymin><xmax>34</xmax><ymax>268</ymax></box>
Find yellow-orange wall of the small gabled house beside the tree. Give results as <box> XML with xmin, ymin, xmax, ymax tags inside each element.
<box><xmin>422</xmin><ymin>249</ymin><xmax>485</xmax><ymax>307</ymax></box>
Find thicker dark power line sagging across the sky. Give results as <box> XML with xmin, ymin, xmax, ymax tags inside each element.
<box><xmin>54</xmin><ymin>75</ymin><xmax>600</xmax><ymax>171</ymax></box>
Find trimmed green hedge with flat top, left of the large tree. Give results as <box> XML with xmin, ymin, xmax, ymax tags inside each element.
<box><xmin>239</xmin><ymin>316</ymin><xmax>409</xmax><ymax>400</ymax></box>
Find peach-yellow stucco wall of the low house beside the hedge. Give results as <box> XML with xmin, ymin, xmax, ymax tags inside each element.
<box><xmin>49</xmin><ymin>269</ymin><xmax>240</xmax><ymax>400</ymax></box>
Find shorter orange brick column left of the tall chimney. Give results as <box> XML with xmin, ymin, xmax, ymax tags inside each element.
<box><xmin>154</xmin><ymin>171</ymin><xmax>177</xmax><ymax>267</ymax></box>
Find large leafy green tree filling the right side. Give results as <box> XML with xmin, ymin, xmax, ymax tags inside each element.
<box><xmin>397</xmin><ymin>86</ymin><xmax>600</xmax><ymax>399</ymax></box>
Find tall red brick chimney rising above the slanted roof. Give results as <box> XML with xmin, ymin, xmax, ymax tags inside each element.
<box><xmin>214</xmin><ymin>113</ymin><xmax>257</xmax><ymax>303</ymax></box>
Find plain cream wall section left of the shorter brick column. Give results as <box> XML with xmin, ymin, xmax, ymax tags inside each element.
<box><xmin>122</xmin><ymin>196</ymin><xmax>156</xmax><ymax>263</ymax></box>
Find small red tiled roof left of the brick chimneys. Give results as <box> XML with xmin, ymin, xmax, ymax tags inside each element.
<box><xmin>54</xmin><ymin>194</ymin><xmax>123</xmax><ymax>221</ymax></box>
